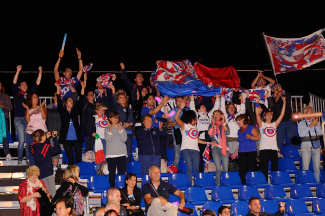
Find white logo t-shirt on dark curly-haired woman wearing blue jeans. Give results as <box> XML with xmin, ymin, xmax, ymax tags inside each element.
<box><xmin>181</xmin><ymin>124</ymin><xmax>200</xmax><ymax>151</ymax></box>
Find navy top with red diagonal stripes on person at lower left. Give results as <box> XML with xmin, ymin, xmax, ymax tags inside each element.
<box><xmin>30</xmin><ymin>137</ymin><xmax>61</xmax><ymax>179</ymax></box>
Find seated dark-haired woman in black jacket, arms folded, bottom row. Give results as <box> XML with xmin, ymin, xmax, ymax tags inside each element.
<box><xmin>120</xmin><ymin>173</ymin><xmax>144</xmax><ymax>215</ymax></box>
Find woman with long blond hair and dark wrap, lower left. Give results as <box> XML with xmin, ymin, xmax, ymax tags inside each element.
<box><xmin>52</xmin><ymin>165</ymin><xmax>89</xmax><ymax>215</ymax></box>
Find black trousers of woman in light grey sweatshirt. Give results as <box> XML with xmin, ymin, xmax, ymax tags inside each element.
<box><xmin>106</xmin><ymin>156</ymin><xmax>126</xmax><ymax>188</ymax></box>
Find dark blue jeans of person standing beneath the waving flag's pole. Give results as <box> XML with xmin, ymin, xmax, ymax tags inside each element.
<box><xmin>276</xmin><ymin>120</ymin><xmax>297</xmax><ymax>149</ymax></box>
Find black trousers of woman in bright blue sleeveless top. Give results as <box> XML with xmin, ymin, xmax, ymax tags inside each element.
<box><xmin>238</xmin><ymin>151</ymin><xmax>257</xmax><ymax>184</ymax></box>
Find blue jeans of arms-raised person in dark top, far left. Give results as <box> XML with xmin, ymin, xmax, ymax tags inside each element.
<box><xmin>14</xmin><ymin>117</ymin><xmax>29</xmax><ymax>161</ymax></box>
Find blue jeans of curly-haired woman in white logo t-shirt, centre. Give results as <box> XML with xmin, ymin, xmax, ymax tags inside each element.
<box><xmin>182</xmin><ymin>149</ymin><xmax>200</xmax><ymax>185</ymax></box>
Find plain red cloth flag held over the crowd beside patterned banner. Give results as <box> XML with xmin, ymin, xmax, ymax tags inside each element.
<box><xmin>194</xmin><ymin>63</ymin><xmax>240</xmax><ymax>88</ymax></box>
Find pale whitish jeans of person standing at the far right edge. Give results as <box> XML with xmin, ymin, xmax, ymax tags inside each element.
<box><xmin>301</xmin><ymin>144</ymin><xmax>320</xmax><ymax>182</ymax></box>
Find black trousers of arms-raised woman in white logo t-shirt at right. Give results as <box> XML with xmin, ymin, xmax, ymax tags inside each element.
<box><xmin>260</xmin><ymin>149</ymin><xmax>278</xmax><ymax>182</ymax></box>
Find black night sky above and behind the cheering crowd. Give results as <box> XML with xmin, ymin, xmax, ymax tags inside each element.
<box><xmin>0</xmin><ymin>1</ymin><xmax>325</xmax><ymax>102</ymax></box>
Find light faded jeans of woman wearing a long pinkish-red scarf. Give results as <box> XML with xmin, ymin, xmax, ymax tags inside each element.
<box><xmin>211</xmin><ymin>147</ymin><xmax>229</xmax><ymax>185</ymax></box>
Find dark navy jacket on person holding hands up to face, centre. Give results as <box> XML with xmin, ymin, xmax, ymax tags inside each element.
<box><xmin>137</xmin><ymin>127</ymin><xmax>167</xmax><ymax>155</ymax></box>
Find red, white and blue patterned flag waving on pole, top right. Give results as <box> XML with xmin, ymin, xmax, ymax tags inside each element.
<box><xmin>264</xmin><ymin>29</ymin><xmax>325</xmax><ymax>74</ymax></box>
